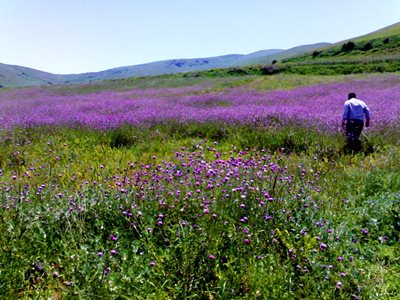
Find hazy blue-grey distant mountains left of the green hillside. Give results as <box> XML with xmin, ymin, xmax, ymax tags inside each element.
<box><xmin>0</xmin><ymin>43</ymin><xmax>329</xmax><ymax>88</ymax></box>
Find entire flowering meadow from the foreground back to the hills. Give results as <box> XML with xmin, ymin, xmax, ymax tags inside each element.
<box><xmin>0</xmin><ymin>75</ymin><xmax>400</xmax><ymax>299</ymax></box>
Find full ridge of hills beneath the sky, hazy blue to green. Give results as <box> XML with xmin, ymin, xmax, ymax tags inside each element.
<box><xmin>0</xmin><ymin>22</ymin><xmax>400</xmax><ymax>88</ymax></box>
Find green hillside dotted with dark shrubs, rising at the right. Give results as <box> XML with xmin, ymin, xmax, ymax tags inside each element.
<box><xmin>182</xmin><ymin>23</ymin><xmax>400</xmax><ymax>77</ymax></box>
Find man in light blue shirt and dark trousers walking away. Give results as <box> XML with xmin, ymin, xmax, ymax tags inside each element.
<box><xmin>342</xmin><ymin>93</ymin><xmax>370</xmax><ymax>151</ymax></box>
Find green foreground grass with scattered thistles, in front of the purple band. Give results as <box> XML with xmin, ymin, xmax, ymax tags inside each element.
<box><xmin>0</xmin><ymin>123</ymin><xmax>400</xmax><ymax>299</ymax></box>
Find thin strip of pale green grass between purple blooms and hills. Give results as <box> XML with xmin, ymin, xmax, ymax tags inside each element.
<box><xmin>30</xmin><ymin>71</ymin><xmax>394</xmax><ymax>95</ymax></box>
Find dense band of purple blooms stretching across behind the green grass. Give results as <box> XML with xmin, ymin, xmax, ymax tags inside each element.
<box><xmin>0</xmin><ymin>75</ymin><xmax>400</xmax><ymax>131</ymax></box>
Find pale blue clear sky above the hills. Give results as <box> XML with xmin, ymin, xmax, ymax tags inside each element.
<box><xmin>0</xmin><ymin>0</ymin><xmax>400</xmax><ymax>74</ymax></box>
